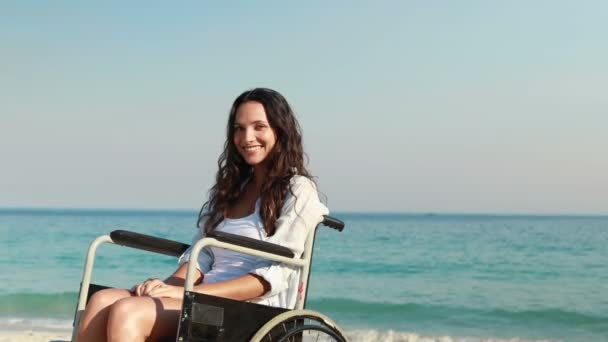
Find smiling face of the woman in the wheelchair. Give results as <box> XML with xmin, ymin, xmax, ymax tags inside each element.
<box><xmin>233</xmin><ymin>101</ymin><xmax>277</xmax><ymax>166</ymax></box>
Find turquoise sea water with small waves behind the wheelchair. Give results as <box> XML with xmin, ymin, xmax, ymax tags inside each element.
<box><xmin>0</xmin><ymin>209</ymin><xmax>608</xmax><ymax>341</ymax></box>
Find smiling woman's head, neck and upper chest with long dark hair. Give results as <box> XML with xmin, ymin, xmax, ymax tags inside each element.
<box><xmin>204</xmin><ymin>88</ymin><xmax>311</xmax><ymax>235</ymax></box>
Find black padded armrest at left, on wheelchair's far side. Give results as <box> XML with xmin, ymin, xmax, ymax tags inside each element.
<box><xmin>110</xmin><ymin>230</ymin><xmax>190</xmax><ymax>257</ymax></box>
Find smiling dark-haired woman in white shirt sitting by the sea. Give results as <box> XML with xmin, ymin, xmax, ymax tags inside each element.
<box><xmin>77</xmin><ymin>88</ymin><xmax>328</xmax><ymax>342</ymax></box>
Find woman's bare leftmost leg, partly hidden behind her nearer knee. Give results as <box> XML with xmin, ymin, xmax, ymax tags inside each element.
<box><xmin>76</xmin><ymin>289</ymin><xmax>132</xmax><ymax>342</ymax></box>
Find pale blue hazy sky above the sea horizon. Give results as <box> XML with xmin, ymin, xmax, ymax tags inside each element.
<box><xmin>0</xmin><ymin>0</ymin><xmax>608</xmax><ymax>214</ymax></box>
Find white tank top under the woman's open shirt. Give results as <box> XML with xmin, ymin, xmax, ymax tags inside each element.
<box><xmin>203</xmin><ymin>200</ymin><xmax>267</xmax><ymax>283</ymax></box>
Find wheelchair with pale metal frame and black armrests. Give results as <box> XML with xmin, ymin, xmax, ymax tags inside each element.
<box><xmin>72</xmin><ymin>215</ymin><xmax>347</xmax><ymax>342</ymax></box>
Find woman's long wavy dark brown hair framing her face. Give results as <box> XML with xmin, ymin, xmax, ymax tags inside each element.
<box><xmin>197</xmin><ymin>88</ymin><xmax>312</xmax><ymax>236</ymax></box>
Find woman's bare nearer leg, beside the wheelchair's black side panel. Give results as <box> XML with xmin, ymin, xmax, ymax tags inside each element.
<box><xmin>107</xmin><ymin>296</ymin><xmax>182</xmax><ymax>342</ymax></box>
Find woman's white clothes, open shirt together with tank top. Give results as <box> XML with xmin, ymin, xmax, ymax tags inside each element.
<box><xmin>178</xmin><ymin>176</ymin><xmax>329</xmax><ymax>309</ymax></box>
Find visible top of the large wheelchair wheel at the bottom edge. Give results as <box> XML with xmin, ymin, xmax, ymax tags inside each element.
<box><xmin>251</xmin><ymin>310</ymin><xmax>346</xmax><ymax>342</ymax></box>
